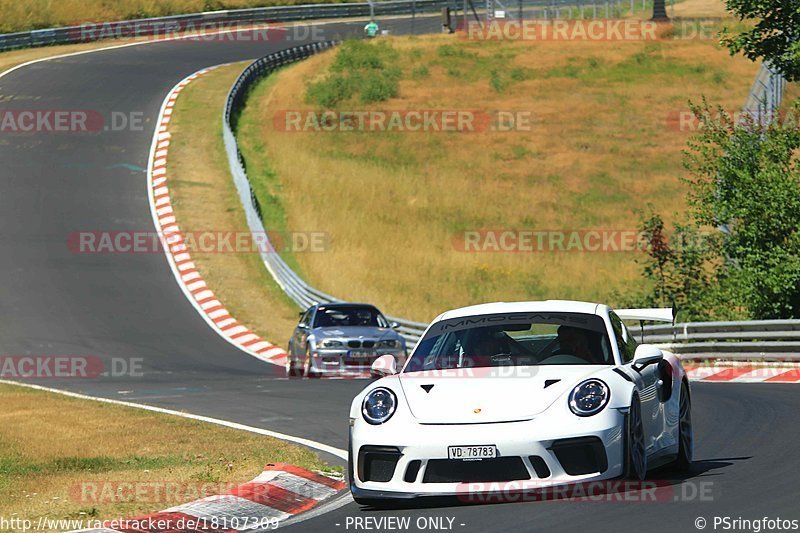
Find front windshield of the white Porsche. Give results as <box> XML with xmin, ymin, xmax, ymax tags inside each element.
<box><xmin>404</xmin><ymin>313</ymin><xmax>614</xmax><ymax>372</ymax></box>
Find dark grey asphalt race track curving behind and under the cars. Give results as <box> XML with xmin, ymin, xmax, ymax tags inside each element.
<box><xmin>0</xmin><ymin>19</ymin><xmax>800</xmax><ymax>531</ymax></box>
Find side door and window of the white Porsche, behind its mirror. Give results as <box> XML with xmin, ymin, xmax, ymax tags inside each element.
<box><xmin>611</xmin><ymin>312</ymin><xmax>663</xmax><ymax>453</ymax></box>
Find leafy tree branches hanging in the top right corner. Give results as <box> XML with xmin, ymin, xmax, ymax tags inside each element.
<box><xmin>722</xmin><ymin>0</ymin><xmax>800</xmax><ymax>81</ymax></box>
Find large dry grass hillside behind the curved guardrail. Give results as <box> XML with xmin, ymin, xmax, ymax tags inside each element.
<box><xmin>242</xmin><ymin>36</ymin><xmax>757</xmax><ymax>320</ymax></box>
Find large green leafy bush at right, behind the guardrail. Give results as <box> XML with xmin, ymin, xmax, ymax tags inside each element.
<box><xmin>642</xmin><ymin>101</ymin><xmax>800</xmax><ymax>319</ymax></box>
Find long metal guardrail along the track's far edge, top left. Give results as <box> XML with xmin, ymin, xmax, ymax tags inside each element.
<box><xmin>0</xmin><ymin>0</ymin><xmax>451</xmax><ymax>51</ymax></box>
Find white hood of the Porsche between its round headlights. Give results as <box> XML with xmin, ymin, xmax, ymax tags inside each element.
<box><xmin>399</xmin><ymin>365</ymin><xmax>608</xmax><ymax>424</ymax></box>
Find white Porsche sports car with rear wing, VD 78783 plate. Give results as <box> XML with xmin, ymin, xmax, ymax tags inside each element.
<box><xmin>349</xmin><ymin>301</ymin><xmax>692</xmax><ymax>505</ymax></box>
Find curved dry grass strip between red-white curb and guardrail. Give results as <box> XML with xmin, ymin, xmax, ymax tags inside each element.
<box><xmin>168</xmin><ymin>63</ymin><xmax>297</xmax><ymax>345</ymax></box>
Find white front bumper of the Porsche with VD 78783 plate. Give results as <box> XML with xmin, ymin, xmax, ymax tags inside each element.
<box><xmin>350</xmin><ymin>409</ymin><xmax>625</xmax><ymax>499</ymax></box>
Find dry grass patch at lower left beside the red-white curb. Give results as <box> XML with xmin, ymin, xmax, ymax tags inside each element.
<box><xmin>0</xmin><ymin>385</ymin><xmax>324</xmax><ymax>520</ymax></box>
